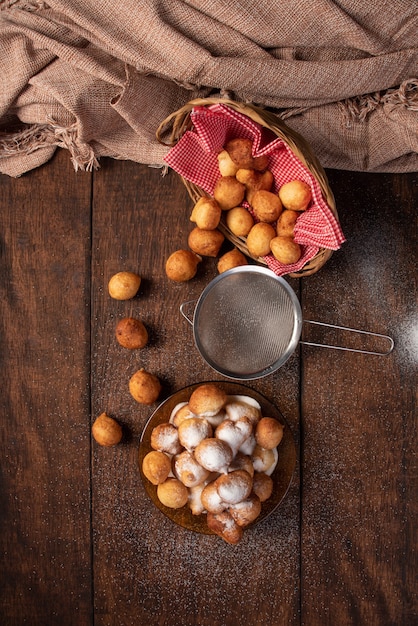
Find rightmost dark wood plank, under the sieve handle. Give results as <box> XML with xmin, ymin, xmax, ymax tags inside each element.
<box><xmin>302</xmin><ymin>172</ymin><xmax>417</xmax><ymax>626</ymax></box>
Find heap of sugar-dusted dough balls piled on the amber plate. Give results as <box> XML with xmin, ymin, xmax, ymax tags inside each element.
<box><xmin>142</xmin><ymin>383</ymin><xmax>283</xmax><ymax>544</ymax></box>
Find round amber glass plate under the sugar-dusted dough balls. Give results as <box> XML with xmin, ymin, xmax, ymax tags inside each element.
<box><xmin>139</xmin><ymin>381</ymin><xmax>296</xmax><ymax>535</ymax></box>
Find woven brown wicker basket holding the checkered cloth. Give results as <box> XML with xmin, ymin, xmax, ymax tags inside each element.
<box><xmin>156</xmin><ymin>98</ymin><xmax>338</xmax><ymax>278</ymax></box>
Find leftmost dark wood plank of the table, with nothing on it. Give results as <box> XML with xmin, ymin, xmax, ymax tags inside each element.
<box><xmin>0</xmin><ymin>152</ymin><xmax>92</xmax><ymax>626</ymax></box>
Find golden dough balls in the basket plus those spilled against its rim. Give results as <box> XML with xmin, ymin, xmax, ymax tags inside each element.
<box><xmin>166</xmin><ymin>138</ymin><xmax>312</xmax><ymax>282</ymax></box>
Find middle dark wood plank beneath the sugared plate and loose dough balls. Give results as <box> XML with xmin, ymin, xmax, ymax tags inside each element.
<box><xmin>92</xmin><ymin>161</ymin><xmax>299</xmax><ymax>626</ymax></box>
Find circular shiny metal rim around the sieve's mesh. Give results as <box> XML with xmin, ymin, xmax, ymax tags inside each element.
<box><xmin>192</xmin><ymin>265</ymin><xmax>302</xmax><ymax>381</ymax></box>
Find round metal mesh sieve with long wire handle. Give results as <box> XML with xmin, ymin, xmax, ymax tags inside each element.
<box><xmin>180</xmin><ymin>265</ymin><xmax>394</xmax><ymax>380</ymax></box>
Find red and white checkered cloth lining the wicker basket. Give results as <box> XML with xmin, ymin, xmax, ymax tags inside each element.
<box><xmin>164</xmin><ymin>104</ymin><xmax>345</xmax><ymax>276</ymax></box>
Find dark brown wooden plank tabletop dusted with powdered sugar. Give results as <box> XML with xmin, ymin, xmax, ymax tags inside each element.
<box><xmin>0</xmin><ymin>151</ymin><xmax>418</xmax><ymax>626</ymax></box>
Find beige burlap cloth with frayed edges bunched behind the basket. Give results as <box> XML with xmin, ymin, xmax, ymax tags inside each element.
<box><xmin>0</xmin><ymin>0</ymin><xmax>418</xmax><ymax>176</ymax></box>
